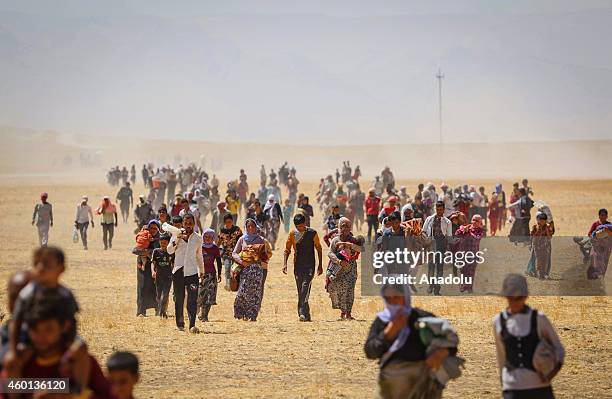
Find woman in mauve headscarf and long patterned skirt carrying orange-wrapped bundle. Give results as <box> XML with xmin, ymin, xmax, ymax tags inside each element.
<box><xmin>232</xmin><ymin>219</ymin><xmax>272</xmax><ymax>321</ymax></box>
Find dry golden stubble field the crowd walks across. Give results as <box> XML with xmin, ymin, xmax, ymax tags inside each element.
<box><xmin>0</xmin><ymin>176</ymin><xmax>612</xmax><ymax>398</ymax></box>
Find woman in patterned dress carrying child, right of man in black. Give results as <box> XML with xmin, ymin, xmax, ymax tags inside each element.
<box><xmin>327</xmin><ymin>217</ymin><xmax>361</xmax><ymax>320</ymax></box>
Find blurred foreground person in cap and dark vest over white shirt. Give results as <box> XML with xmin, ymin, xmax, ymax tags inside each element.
<box><xmin>493</xmin><ymin>274</ymin><xmax>565</xmax><ymax>399</ymax></box>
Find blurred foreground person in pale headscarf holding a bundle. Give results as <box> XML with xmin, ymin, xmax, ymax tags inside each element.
<box><xmin>364</xmin><ymin>284</ymin><xmax>459</xmax><ymax>399</ymax></box>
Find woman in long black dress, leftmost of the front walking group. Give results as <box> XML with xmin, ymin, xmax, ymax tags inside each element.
<box><xmin>133</xmin><ymin>220</ymin><xmax>160</xmax><ymax>317</ymax></box>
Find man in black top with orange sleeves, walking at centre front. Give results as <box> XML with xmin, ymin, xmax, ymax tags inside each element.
<box><xmin>283</xmin><ymin>214</ymin><xmax>323</xmax><ymax>321</ymax></box>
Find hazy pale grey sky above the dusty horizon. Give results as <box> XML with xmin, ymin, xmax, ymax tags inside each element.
<box><xmin>0</xmin><ymin>0</ymin><xmax>612</xmax><ymax>144</ymax></box>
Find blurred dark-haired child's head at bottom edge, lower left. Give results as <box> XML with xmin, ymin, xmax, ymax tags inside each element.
<box><xmin>106</xmin><ymin>352</ymin><xmax>140</xmax><ymax>399</ymax></box>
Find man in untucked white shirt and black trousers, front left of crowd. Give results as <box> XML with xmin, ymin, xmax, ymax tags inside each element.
<box><xmin>168</xmin><ymin>213</ymin><xmax>204</xmax><ymax>333</ymax></box>
